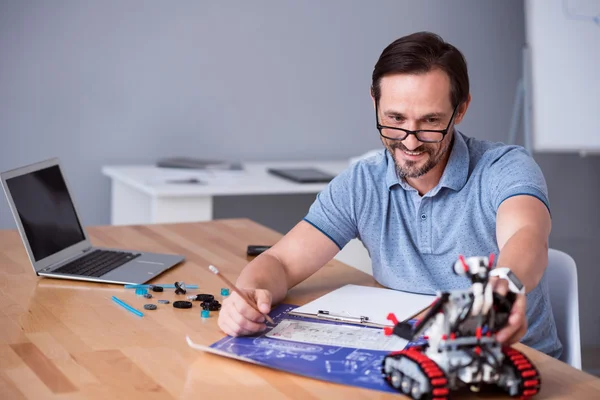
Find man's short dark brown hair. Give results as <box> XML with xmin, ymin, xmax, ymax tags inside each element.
<box><xmin>371</xmin><ymin>32</ymin><xmax>469</xmax><ymax>107</ymax></box>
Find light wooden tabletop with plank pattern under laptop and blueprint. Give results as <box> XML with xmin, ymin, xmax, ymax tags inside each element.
<box><xmin>0</xmin><ymin>219</ymin><xmax>600</xmax><ymax>400</ymax></box>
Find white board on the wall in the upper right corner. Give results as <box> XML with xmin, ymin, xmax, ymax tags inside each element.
<box><xmin>525</xmin><ymin>0</ymin><xmax>600</xmax><ymax>153</ymax></box>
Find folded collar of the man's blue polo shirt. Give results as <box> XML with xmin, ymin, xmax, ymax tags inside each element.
<box><xmin>385</xmin><ymin>130</ymin><xmax>470</xmax><ymax>195</ymax></box>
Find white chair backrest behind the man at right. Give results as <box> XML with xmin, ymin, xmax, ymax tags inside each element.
<box><xmin>546</xmin><ymin>249</ymin><xmax>581</xmax><ymax>369</ymax></box>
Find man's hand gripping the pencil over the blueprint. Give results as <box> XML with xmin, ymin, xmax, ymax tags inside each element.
<box><xmin>218</xmin><ymin>289</ymin><xmax>272</xmax><ymax>337</ymax></box>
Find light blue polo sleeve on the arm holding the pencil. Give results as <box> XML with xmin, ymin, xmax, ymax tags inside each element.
<box><xmin>304</xmin><ymin>167</ymin><xmax>358</xmax><ymax>250</ymax></box>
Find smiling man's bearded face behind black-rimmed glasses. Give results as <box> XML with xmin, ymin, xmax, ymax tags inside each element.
<box><xmin>378</xmin><ymin>69</ymin><xmax>461</xmax><ymax>178</ymax></box>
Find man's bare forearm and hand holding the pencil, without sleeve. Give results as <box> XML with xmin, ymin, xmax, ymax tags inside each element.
<box><xmin>219</xmin><ymin>221</ymin><xmax>340</xmax><ymax>336</ymax></box>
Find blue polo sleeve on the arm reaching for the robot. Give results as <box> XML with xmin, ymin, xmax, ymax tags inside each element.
<box><xmin>486</xmin><ymin>146</ymin><xmax>550</xmax><ymax>211</ymax></box>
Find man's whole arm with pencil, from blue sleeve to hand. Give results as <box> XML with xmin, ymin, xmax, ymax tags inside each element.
<box><xmin>219</xmin><ymin>163</ymin><xmax>369</xmax><ymax>336</ymax></box>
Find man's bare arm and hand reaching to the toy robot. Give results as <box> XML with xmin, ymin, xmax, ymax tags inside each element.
<box><xmin>496</xmin><ymin>195</ymin><xmax>552</xmax><ymax>344</ymax></box>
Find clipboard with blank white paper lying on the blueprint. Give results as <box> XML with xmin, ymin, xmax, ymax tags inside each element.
<box><xmin>289</xmin><ymin>285</ymin><xmax>437</xmax><ymax>328</ymax></box>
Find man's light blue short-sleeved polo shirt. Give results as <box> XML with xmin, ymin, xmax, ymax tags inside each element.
<box><xmin>305</xmin><ymin>131</ymin><xmax>562</xmax><ymax>357</ymax></box>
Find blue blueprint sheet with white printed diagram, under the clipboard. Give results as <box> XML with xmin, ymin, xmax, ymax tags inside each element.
<box><xmin>210</xmin><ymin>304</ymin><xmax>426</xmax><ymax>393</ymax></box>
